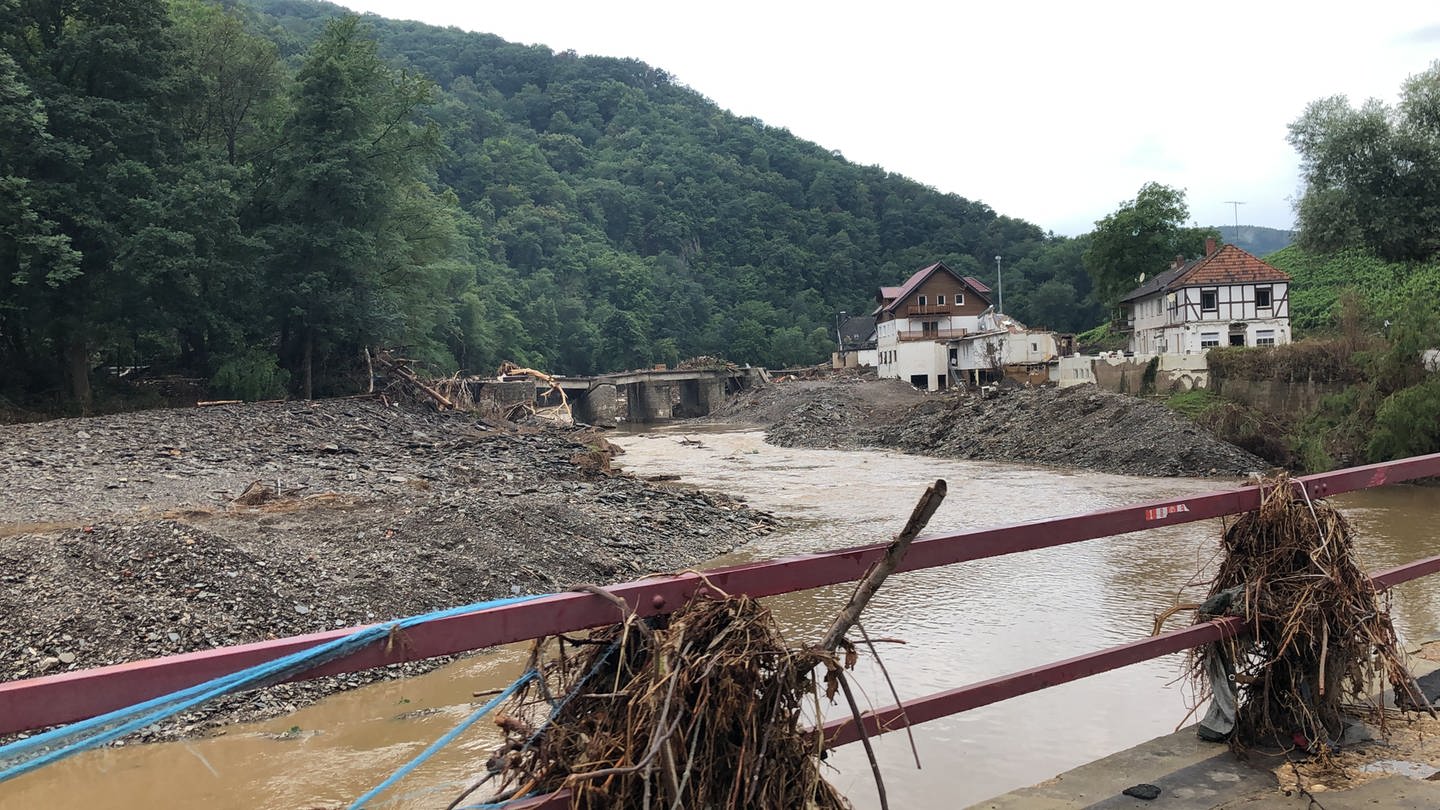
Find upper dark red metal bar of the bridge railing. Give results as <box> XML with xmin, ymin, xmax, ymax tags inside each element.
<box><xmin>0</xmin><ymin>454</ymin><xmax>1440</xmax><ymax>734</ymax></box>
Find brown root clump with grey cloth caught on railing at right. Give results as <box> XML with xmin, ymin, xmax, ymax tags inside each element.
<box><xmin>1192</xmin><ymin>477</ymin><xmax>1428</xmax><ymax>752</ymax></box>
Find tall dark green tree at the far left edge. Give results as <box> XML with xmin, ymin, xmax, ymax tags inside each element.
<box><xmin>0</xmin><ymin>0</ymin><xmax>180</xmax><ymax>406</ymax></box>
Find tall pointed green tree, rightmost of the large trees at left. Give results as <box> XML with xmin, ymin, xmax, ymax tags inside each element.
<box><xmin>264</xmin><ymin>16</ymin><xmax>452</xmax><ymax>398</ymax></box>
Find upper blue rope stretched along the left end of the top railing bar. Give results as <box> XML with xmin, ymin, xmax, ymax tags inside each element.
<box><xmin>0</xmin><ymin>595</ymin><xmax>540</xmax><ymax>783</ymax></box>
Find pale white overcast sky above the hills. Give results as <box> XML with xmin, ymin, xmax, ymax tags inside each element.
<box><xmin>341</xmin><ymin>0</ymin><xmax>1440</xmax><ymax>235</ymax></box>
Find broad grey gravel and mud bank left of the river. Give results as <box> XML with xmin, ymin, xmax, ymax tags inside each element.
<box><xmin>0</xmin><ymin>399</ymin><xmax>773</xmax><ymax>736</ymax></box>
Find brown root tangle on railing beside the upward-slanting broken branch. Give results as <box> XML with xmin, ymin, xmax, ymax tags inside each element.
<box><xmin>466</xmin><ymin>597</ymin><xmax>848</xmax><ymax>810</ymax></box>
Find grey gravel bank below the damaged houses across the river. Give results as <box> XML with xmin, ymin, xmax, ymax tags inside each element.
<box><xmin>713</xmin><ymin>378</ymin><xmax>1270</xmax><ymax>477</ymax></box>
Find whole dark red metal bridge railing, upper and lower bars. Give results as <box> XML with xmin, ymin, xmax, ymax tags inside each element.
<box><xmin>0</xmin><ymin>454</ymin><xmax>1440</xmax><ymax>784</ymax></box>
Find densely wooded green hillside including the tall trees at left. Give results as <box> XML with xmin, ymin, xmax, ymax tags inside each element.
<box><xmin>0</xmin><ymin>0</ymin><xmax>1102</xmax><ymax>404</ymax></box>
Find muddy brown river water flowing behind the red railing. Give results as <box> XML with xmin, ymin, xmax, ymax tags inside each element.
<box><xmin>0</xmin><ymin>427</ymin><xmax>1440</xmax><ymax>810</ymax></box>
